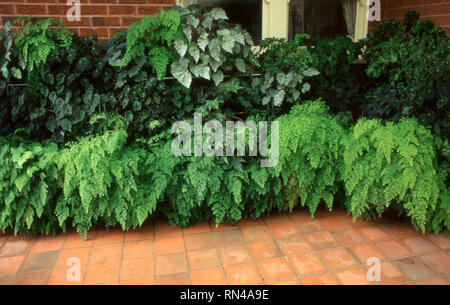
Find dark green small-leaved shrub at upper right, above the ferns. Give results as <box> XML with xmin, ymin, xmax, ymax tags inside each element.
<box><xmin>362</xmin><ymin>12</ymin><xmax>450</xmax><ymax>138</ymax></box>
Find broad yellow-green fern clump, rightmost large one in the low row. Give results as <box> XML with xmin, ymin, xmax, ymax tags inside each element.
<box><xmin>342</xmin><ymin>119</ymin><xmax>440</xmax><ymax>231</ymax></box>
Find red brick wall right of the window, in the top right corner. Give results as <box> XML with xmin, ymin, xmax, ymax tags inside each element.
<box><xmin>369</xmin><ymin>0</ymin><xmax>450</xmax><ymax>35</ymax></box>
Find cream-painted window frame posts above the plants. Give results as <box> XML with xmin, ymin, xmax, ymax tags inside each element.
<box><xmin>177</xmin><ymin>0</ymin><xmax>368</xmax><ymax>41</ymax></box>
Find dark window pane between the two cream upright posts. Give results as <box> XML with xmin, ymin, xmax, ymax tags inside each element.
<box><xmin>289</xmin><ymin>0</ymin><xmax>349</xmax><ymax>39</ymax></box>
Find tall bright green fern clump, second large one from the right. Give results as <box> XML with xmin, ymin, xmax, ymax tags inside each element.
<box><xmin>274</xmin><ymin>101</ymin><xmax>345</xmax><ymax>214</ymax></box>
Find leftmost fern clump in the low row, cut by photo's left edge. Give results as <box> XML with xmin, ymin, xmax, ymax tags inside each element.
<box><xmin>0</xmin><ymin>135</ymin><xmax>59</xmax><ymax>234</ymax></box>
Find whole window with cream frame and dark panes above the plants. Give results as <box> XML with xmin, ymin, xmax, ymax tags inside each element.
<box><xmin>178</xmin><ymin>0</ymin><xmax>368</xmax><ymax>44</ymax></box>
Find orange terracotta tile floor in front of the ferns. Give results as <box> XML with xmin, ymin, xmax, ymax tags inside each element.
<box><xmin>0</xmin><ymin>209</ymin><xmax>450</xmax><ymax>285</ymax></box>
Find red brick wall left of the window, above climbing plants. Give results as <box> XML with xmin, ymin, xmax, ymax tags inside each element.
<box><xmin>0</xmin><ymin>0</ymin><xmax>175</xmax><ymax>41</ymax></box>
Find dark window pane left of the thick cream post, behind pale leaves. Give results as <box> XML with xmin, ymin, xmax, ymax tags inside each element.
<box><xmin>197</xmin><ymin>0</ymin><xmax>263</xmax><ymax>44</ymax></box>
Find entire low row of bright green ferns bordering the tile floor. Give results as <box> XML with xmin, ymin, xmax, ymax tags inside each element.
<box><xmin>0</xmin><ymin>101</ymin><xmax>450</xmax><ymax>236</ymax></box>
